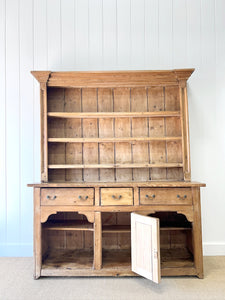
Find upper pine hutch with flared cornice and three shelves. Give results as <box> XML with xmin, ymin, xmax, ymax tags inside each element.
<box><xmin>32</xmin><ymin>69</ymin><xmax>193</xmax><ymax>182</ymax></box>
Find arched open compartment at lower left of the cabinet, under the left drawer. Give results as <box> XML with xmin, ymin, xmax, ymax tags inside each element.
<box><xmin>42</xmin><ymin>212</ymin><xmax>94</xmax><ymax>270</ymax></box>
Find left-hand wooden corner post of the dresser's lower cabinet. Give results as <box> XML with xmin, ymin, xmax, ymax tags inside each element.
<box><xmin>34</xmin><ymin>188</ymin><xmax>42</xmax><ymax>279</ymax></box>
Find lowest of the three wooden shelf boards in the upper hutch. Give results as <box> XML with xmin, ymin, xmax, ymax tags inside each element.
<box><xmin>48</xmin><ymin>163</ymin><xmax>183</xmax><ymax>169</ymax></box>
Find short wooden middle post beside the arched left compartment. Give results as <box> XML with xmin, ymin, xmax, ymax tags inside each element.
<box><xmin>94</xmin><ymin>212</ymin><xmax>102</xmax><ymax>270</ymax></box>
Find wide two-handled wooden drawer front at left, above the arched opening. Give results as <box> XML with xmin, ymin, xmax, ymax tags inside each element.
<box><xmin>41</xmin><ymin>188</ymin><xmax>94</xmax><ymax>205</ymax></box>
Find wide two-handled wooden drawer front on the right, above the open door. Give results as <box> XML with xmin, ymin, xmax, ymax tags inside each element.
<box><xmin>140</xmin><ymin>188</ymin><xmax>192</xmax><ymax>205</ymax></box>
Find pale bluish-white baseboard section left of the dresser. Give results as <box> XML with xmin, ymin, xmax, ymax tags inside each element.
<box><xmin>0</xmin><ymin>243</ymin><xmax>33</xmax><ymax>257</ymax></box>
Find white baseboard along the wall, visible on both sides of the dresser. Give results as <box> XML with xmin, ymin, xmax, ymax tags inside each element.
<box><xmin>0</xmin><ymin>243</ymin><xmax>225</xmax><ymax>257</ymax></box>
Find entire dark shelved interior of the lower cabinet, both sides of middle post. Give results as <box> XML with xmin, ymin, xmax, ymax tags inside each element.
<box><xmin>42</xmin><ymin>212</ymin><xmax>194</xmax><ymax>269</ymax></box>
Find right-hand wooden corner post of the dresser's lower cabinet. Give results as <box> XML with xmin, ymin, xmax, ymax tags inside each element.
<box><xmin>193</xmin><ymin>188</ymin><xmax>204</xmax><ymax>278</ymax></box>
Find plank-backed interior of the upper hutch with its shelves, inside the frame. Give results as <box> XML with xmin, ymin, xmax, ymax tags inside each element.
<box><xmin>47</xmin><ymin>85</ymin><xmax>184</xmax><ymax>182</ymax></box>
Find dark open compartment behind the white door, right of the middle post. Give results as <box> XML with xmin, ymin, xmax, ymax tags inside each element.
<box><xmin>102</xmin><ymin>212</ymin><xmax>194</xmax><ymax>270</ymax></box>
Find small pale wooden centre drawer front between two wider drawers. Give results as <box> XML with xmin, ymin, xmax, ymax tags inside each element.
<box><xmin>101</xmin><ymin>188</ymin><xmax>133</xmax><ymax>205</ymax></box>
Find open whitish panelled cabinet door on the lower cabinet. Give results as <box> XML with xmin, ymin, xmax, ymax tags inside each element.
<box><xmin>131</xmin><ymin>213</ymin><xmax>161</xmax><ymax>283</ymax></box>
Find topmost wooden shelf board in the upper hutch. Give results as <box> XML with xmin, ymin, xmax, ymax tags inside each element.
<box><xmin>48</xmin><ymin>111</ymin><xmax>181</xmax><ymax>119</ymax></box>
